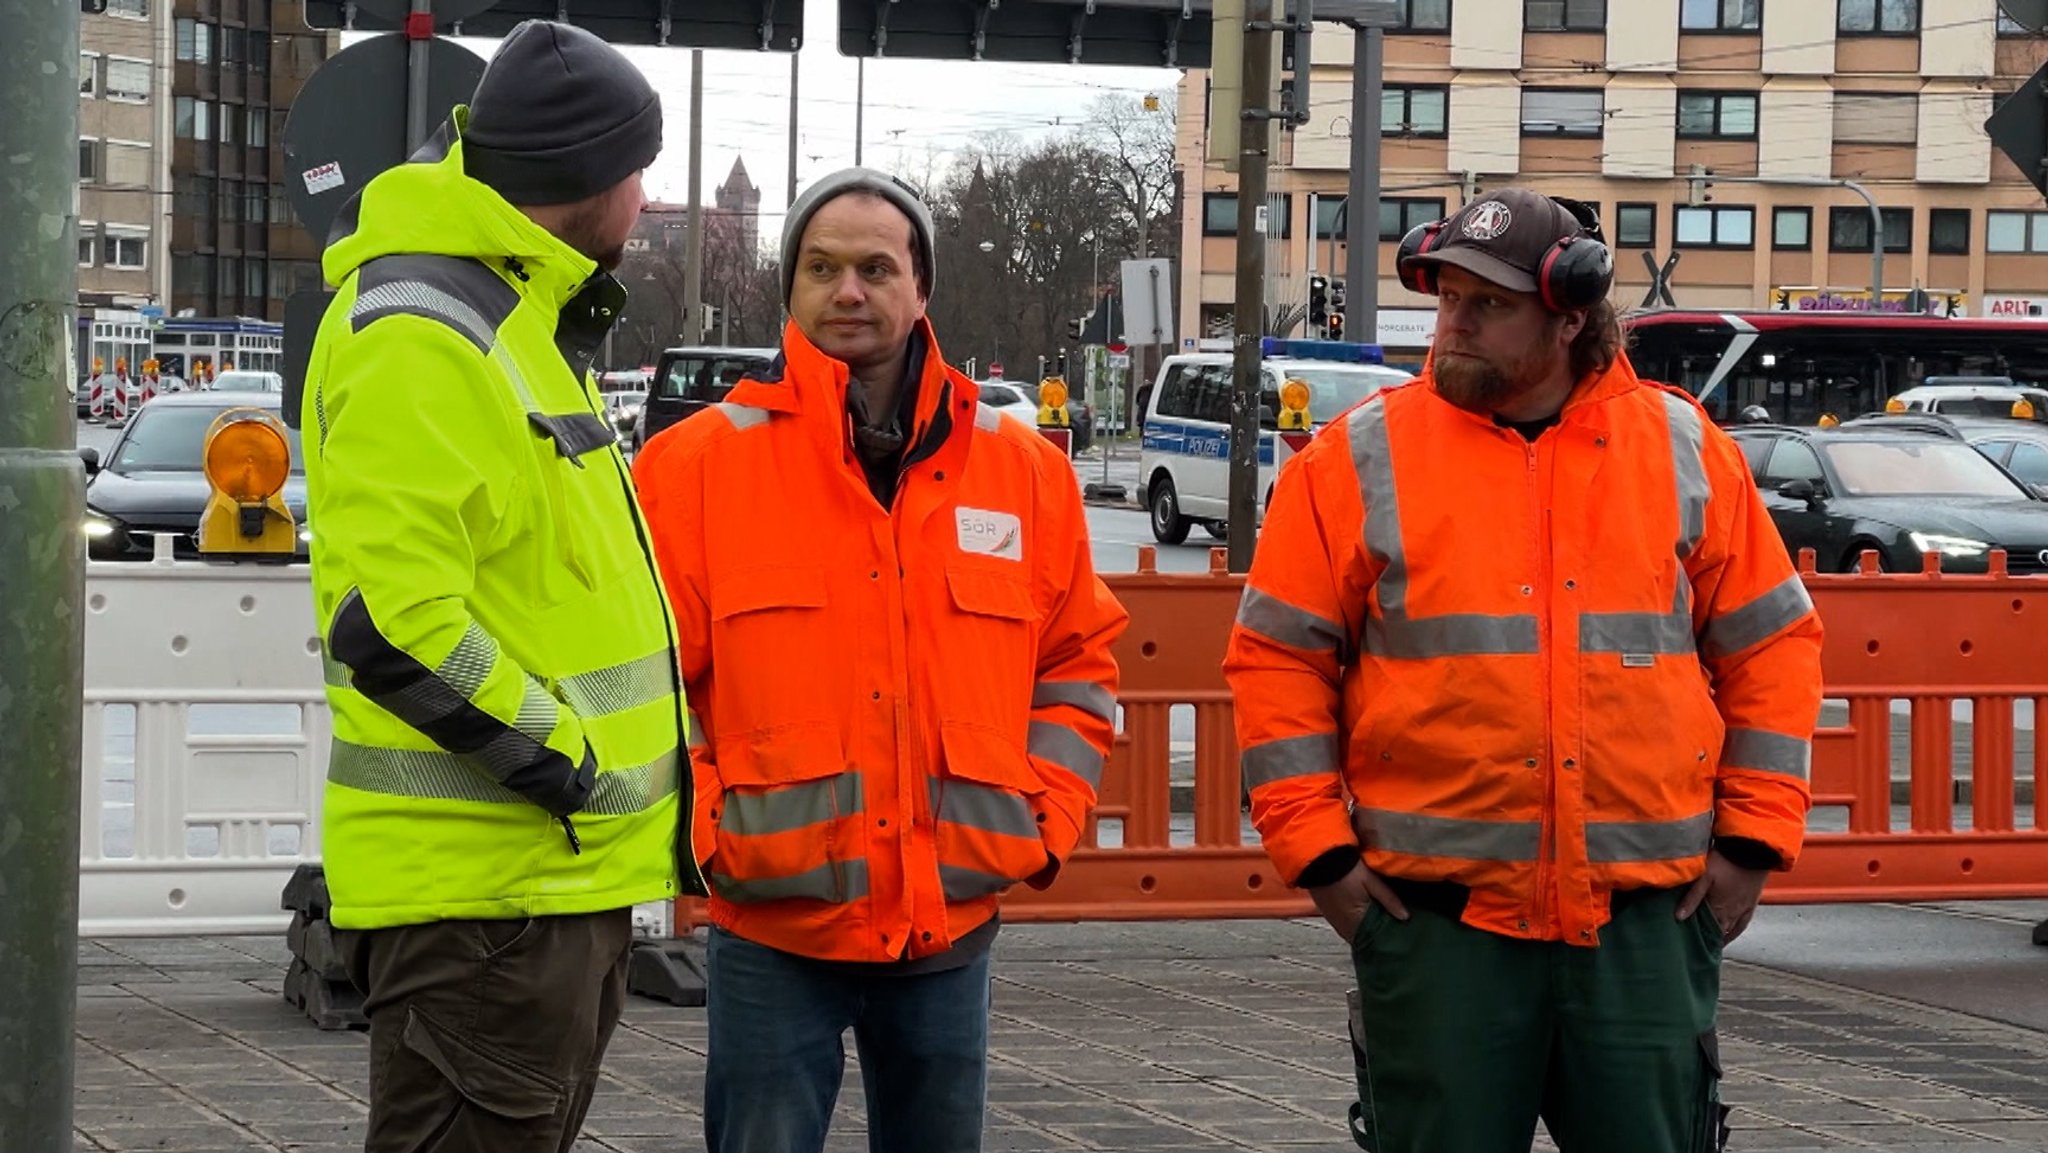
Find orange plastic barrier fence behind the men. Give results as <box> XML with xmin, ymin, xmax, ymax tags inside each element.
<box><xmin>678</xmin><ymin>549</ymin><xmax>2048</xmax><ymax>932</ymax></box>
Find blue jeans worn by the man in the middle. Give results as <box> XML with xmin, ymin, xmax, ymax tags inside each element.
<box><xmin>705</xmin><ymin>928</ymin><xmax>989</xmax><ymax>1153</ymax></box>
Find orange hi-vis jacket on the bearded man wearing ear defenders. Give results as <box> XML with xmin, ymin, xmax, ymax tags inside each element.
<box><xmin>1225</xmin><ymin>358</ymin><xmax>1821</xmax><ymax>944</ymax></box>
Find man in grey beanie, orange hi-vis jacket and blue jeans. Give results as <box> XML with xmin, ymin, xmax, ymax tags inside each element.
<box><xmin>635</xmin><ymin>168</ymin><xmax>1126</xmax><ymax>1153</ymax></box>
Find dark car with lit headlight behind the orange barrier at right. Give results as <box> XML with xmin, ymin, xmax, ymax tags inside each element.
<box><xmin>1729</xmin><ymin>416</ymin><xmax>2048</xmax><ymax>573</ymax></box>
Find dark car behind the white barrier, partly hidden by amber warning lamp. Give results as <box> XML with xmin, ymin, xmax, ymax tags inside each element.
<box><xmin>78</xmin><ymin>391</ymin><xmax>313</xmax><ymax>561</ymax></box>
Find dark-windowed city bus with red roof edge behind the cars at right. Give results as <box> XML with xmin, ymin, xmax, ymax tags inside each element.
<box><xmin>1624</xmin><ymin>309</ymin><xmax>2048</xmax><ymax>424</ymax></box>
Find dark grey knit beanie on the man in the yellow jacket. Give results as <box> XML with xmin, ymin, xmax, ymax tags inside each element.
<box><xmin>463</xmin><ymin>20</ymin><xmax>662</xmax><ymax>205</ymax></box>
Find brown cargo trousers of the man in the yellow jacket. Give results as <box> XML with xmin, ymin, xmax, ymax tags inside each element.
<box><xmin>336</xmin><ymin>909</ymin><xmax>633</xmax><ymax>1153</ymax></box>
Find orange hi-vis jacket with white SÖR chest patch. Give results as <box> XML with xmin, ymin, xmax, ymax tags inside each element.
<box><xmin>635</xmin><ymin>322</ymin><xmax>1128</xmax><ymax>960</ymax></box>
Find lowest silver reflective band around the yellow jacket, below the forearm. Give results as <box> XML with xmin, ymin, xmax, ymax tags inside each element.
<box><xmin>328</xmin><ymin>737</ymin><xmax>678</xmax><ymax>817</ymax></box>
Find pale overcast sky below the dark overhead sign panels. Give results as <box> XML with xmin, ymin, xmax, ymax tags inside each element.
<box><xmin>348</xmin><ymin>0</ymin><xmax>1180</xmax><ymax>224</ymax></box>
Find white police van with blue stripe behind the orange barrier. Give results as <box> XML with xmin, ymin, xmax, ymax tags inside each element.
<box><xmin>1139</xmin><ymin>336</ymin><xmax>1409</xmax><ymax>545</ymax></box>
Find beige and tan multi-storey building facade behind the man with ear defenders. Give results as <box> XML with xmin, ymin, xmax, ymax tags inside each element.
<box><xmin>1180</xmin><ymin>0</ymin><xmax>2048</xmax><ymax>344</ymax></box>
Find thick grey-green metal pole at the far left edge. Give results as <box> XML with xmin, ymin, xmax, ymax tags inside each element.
<box><xmin>0</xmin><ymin>0</ymin><xmax>86</xmax><ymax>1153</ymax></box>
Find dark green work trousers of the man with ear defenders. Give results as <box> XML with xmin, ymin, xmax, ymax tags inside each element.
<box><xmin>1352</xmin><ymin>885</ymin><xmax>1726</xmax><ymax>1153</ymax></box>
